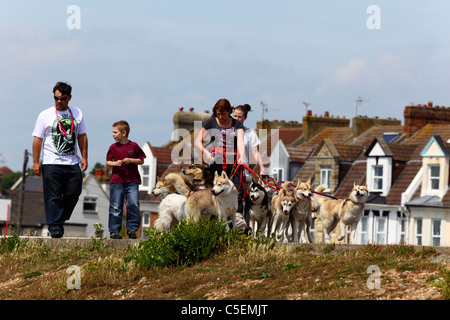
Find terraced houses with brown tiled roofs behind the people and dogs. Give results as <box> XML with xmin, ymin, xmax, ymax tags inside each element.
<box><xmin>0</xmin><ymin>102</ymin><xmax>450</xmax><ymax>246</ymax></box>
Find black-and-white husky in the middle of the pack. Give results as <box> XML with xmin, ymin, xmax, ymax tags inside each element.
<box><xmin>244</xmin><ymin>179</ymin><xmax>270</xmax><ymax>238</ymax></box>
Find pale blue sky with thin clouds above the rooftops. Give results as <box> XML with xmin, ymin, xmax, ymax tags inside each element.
<box><xmin>0</xmin><ymin>0</ymin><xmax>450</xmax><ymax>171</ymax></box>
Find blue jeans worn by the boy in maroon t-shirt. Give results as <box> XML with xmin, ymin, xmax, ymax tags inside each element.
<box><xmin>108</xmin><ymin>182</ymin><xmax>141</xmax><ymax>233</ymax></box>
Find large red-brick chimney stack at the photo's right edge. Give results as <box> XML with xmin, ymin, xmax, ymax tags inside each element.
<box><xmin>404</xmin><ymin>101</ymin><xmax>450</xmax><ymax>138</ymax></box>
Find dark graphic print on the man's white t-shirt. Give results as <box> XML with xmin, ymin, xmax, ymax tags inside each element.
<box><xmin>52</xmin><ymin>114</ymin><xmax>78</xmax><ymax>156</ymax></box>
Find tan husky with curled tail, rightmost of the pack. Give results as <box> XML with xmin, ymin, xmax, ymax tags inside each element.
<box><xmin>314</xmin><ymin>182</ymin><xmax>369</xmax><ymax>243</ymax></box>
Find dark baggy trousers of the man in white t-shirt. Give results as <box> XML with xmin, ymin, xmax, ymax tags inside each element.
<box><xmin>42</xmin><ymin>164</ymin><xmax>83</xmax><ymax>232</ymax></box>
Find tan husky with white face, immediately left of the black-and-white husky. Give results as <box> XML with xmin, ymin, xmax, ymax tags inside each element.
<box><xmin>186</xmin><ymin>171</ymin><xmax>238</xmax><ymax>226</ymax></box>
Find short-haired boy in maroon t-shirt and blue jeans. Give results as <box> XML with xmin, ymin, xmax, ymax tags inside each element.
<box><xmin>106</xmin><ymin>120</ymin><xmax>146</xmax><ymax>239</ymax></box>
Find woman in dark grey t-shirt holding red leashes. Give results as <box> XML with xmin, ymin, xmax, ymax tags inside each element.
<box><xmin>195</xmin><ymin>99</ymin><xmax>245</xmax><ymax>218</ymax></box>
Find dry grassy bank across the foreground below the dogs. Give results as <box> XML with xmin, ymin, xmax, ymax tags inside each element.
<box><xmin>0</xmin><ymin>235</ymin><xmax>448</xmax><ymax>300</ymax></box>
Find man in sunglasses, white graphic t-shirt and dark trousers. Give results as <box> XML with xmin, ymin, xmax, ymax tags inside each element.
<box><xmin>33</xmin><ymin>82</ymin><xmax>88</xmax><ymax>238</ymax></box>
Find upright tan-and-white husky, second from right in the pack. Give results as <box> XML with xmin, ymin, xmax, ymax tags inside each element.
<box><xmin>291</xmin><ymin>179</ymin><xmax>313</xmax><ymax>243</ymax></box>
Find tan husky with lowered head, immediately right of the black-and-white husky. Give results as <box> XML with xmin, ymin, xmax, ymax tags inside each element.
<box><xmin>269</xmin><ymin>182</ymin><xmax>296</xmax><ymax>241</ymax></box>
